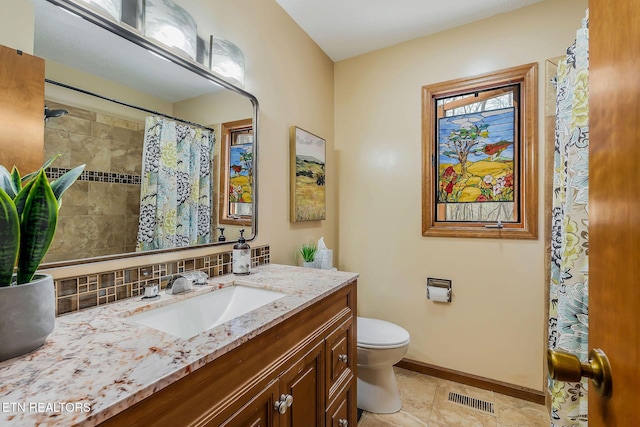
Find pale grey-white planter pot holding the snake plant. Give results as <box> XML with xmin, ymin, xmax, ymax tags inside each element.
<box><xmin>0</xmin><ymin>274</ymin><xmax>56</xmax><ymax>362</ymax></box>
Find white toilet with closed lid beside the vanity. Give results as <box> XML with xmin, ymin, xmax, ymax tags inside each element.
<box><xmin>358</xmin><ymin>317</ymin><xmax>410</xmax><ymax>414</ymax></box>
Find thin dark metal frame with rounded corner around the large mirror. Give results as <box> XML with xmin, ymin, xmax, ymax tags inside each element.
<box><xmin>41</xmin><ymin>0</ymin><xmax>259</xmax><ymax>269</ymax></box>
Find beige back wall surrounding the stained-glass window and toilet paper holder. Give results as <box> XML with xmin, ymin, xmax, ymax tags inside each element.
<box><xmin>334</xmin><ymin>0</ymin><xmax>587</xmax><ymax>390</ymax></box>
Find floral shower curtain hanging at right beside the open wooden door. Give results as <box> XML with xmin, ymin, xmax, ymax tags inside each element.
<box><xmin>549</xmin><ymin>12</ymin><xmax>589</xmax><ymax>427</ymax></box>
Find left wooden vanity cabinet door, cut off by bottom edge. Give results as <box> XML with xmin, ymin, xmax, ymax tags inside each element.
<box><xmin>219</xmin><ymin>380</ymin><xmax>279</xmax><ymax>427</ymax></box>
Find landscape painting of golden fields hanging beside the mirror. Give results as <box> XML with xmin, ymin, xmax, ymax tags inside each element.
<box><xmin>289</xmin><ymin>126</ymin><xmax>327</xmax><ymax>222</ymax></box>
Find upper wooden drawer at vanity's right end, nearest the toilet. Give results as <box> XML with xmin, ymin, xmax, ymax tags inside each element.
<box><xmin>325</xmin><ymin>316</ymin><xmax>356</xmax><ymax>402</ymax></box>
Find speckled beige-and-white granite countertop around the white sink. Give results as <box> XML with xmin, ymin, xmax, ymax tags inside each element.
<box><xmin>0</xmin><ymin>264</ymin><xmax>358</xmax><ymax>426</ymax></box>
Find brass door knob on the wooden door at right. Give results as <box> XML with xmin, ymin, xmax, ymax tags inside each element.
<box><xmin>547</xmin><ymin>348</ymin><xmax>613</xmax><ymax>397</ymax></box>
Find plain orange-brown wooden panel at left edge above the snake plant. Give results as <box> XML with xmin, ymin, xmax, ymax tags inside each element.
<box><xmin>0</xmin><ymin>45</ymin><xmax>44</xmax><ymax>175</ymax></box>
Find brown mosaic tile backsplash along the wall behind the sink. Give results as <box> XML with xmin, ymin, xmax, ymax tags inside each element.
<box><xmin>54</xmin><ymin>245</ymin><xmax>270</xmax><ymax>316</ymax></box>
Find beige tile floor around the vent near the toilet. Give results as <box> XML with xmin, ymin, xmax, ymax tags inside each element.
<box><xmin>358</xmin><ymin>368</ymin><xmax>550</xmax><ymax>427</ymax></box>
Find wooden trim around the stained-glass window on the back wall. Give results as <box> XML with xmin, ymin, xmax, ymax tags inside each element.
<box><xmin>422</xmin><ymin>63</ymin><xmax>538</xmax><ymax>239</ymax></box>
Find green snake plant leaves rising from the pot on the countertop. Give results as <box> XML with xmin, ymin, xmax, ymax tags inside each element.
<box><xmin>0</xmin><ymin>156</ymin><xmax>85</xmax><ymax>287</ymax></box>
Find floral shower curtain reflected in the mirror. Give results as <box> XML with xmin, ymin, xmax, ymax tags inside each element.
<box><xmin>136</xmin><ymin>117</ymin><xmax>215</xmax><ymax>251</ymax></box>
